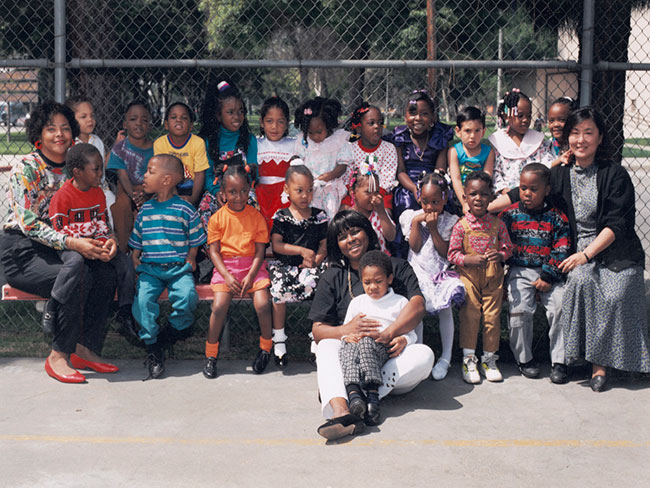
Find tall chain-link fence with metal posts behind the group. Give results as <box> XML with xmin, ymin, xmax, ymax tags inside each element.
<box><xmin>0</xmin><ymin>0</ymin><xmax>650</xmax><ymax>358</ymax></box>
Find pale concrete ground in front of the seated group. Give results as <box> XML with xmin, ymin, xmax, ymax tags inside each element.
<box><xmin>0</xmin><ymin>358</ymin><xmax>650</xmax><ymax>488</ymax></box>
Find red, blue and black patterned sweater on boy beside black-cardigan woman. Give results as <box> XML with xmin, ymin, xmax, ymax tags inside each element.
<box><xmin>501</xmin><ymin>202</ymin><xmax>570</xmax><ymax>283</ymax></box>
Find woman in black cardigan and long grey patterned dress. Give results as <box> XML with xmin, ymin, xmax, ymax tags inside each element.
<box><xmin>494</xmin><ymin>107</ymin><xmax>650</xmax><ymax>391</ymax></box>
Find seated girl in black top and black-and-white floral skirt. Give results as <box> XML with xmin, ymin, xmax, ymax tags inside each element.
<box><xmin>268</xmin><ymin>161</ymin><xmax>328</xmax><ymax>367</ymax></box>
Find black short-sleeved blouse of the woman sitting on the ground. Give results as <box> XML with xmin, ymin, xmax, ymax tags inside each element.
<box><xmin>309</xmin><ymin>258</ymin><xmax>422</xmax><ymax>326</ymax></box>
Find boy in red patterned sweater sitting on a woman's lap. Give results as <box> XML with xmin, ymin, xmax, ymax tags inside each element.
<box><xmin>50</xmin><ymin>143</ymin><xmax>137</xmax><ymax>337</ymax></box>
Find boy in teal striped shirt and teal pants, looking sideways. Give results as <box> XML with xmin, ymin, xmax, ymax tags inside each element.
<box><xmin>129</xmin><ymin>155</ymin><xmax>206</xmax><ymax>378</ymax></box>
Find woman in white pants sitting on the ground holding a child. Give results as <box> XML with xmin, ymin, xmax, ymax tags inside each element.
<box><xmin>309</xmin><ymin>210</ymin><xmax>434</xmax><ymax>440</ymax></box>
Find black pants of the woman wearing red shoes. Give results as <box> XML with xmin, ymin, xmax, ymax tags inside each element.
<box><xmin>0</xmin><ymin>231</ymin><xmax>116</xmax><ymax>354</ymax></box>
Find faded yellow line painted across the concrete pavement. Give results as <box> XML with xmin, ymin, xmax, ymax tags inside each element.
<box><xmin>0</xmin><ymin>434</ymin><xmax>650</xmax><ymax>448</ymax></box>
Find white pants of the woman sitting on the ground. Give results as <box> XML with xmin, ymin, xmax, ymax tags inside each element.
<box><xmin>316</xmin><ymin>339</ymin><xmax>434</xmax><ymax>418</ymax></box>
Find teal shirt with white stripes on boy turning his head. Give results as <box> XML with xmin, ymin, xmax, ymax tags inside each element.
<box><xmin>129</xmin><ymin>195</ymin><xmax>207</xmax><ymax>264</ymax></box>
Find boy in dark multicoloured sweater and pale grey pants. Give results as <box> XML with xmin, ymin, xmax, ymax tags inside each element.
<box><xmin>501</xmin><ymin>163</ymin><xmax>569</xmax><ymax>384</ymax></box>
